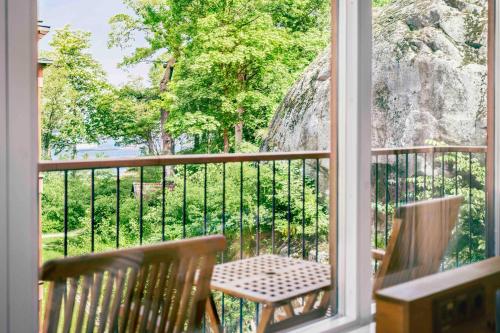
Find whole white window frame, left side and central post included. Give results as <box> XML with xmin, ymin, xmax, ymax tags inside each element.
<box><xmin>5</xmin><ymin>0</ymin><xmax>500</xmax><ymax>332</ymax></box>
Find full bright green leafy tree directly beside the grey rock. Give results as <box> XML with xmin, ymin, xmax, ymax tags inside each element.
<box><xmin>173</xmin><ymin>0</ymin><xmax>327</xmax><ymax>152</ymax></box>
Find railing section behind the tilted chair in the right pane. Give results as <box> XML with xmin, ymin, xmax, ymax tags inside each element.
<box><xmin>372</xmin><ymin>146</ymin><xmax>487</xmax><ymax>269</ymax></box>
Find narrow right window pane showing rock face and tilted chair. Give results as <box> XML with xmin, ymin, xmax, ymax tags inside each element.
<box><xmin>372</xmin><ymin>0</ymin><xmax>488</xmax><ymax>289</ymax></box>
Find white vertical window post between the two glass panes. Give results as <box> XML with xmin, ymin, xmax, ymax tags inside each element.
<box><xmin>296</xmin><ymin>0</ymin><xmax>373</xmax><ymax>332</ymax></box>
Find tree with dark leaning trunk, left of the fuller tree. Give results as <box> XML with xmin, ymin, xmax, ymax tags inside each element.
<box><xmin>109</xmin><ymin>0</ymin><xmax>210</xmax><ymax>154</ymax></box>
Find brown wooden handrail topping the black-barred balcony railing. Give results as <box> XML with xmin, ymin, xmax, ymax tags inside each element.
<box><xmin>38</xmin><ymin>146</ymin><xmax>486</xmax><ymax>172</ymax></box>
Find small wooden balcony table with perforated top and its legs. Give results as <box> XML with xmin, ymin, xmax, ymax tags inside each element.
<box><xmin>207</xmin><ymin>255</ymin><xmax>331</xmax><ymax>333</ymax></box>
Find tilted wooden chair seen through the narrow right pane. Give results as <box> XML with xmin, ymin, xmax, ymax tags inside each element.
<box><xmin>372</xmin><ymin>196</ymin><xmax>463</xmax><ymax>293</ymax></box>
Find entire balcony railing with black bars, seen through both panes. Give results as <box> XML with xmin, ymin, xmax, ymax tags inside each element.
<box><xmin>39</xmin><ymin>147</ymin><xmax>486</xmax><ymax>331</ymax></box>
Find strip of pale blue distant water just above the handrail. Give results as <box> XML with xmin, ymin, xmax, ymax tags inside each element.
<box><xmin>55</xmin><ymin>139</ymin><xmax>141</xmax><ymax>159</ymax></box>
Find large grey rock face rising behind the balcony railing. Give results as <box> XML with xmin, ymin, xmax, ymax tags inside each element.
<box><xmin>263</xmin><ymin>0</ymin><xmax>487</xmax><ymax>151</ymax></box>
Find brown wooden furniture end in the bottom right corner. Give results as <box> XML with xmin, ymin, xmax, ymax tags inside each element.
<box><xmin>375</xmin><ymin>257</ymin><xmax>500</xmax><ymax>333</ymax></box>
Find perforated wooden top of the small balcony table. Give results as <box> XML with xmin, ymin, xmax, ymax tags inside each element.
<box><xmin>211</xmin><ymin>255</ymin><xmax>331</xmax><ymax>304</ymax></box>
